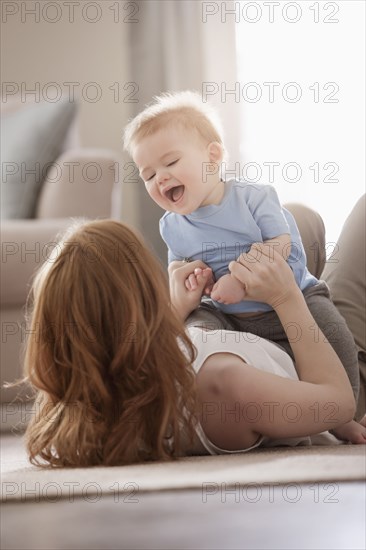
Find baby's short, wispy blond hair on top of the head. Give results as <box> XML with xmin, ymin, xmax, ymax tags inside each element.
<box><xmin>123</xmin><ymin>90</ymin><xmax>225</xmax><ymax>162</ymax></box>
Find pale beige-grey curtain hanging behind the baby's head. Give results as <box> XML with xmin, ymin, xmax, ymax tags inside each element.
<box><xmin>124</xmin><ymin>0</ymin><xmax>239</xmax><ymax>264</ymax></box>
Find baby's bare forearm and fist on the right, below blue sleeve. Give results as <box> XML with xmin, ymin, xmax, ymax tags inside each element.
<box><xmin>210</xmin><ymin>233</ymin><xmax>291</xmax><ymax>304</ymax></box>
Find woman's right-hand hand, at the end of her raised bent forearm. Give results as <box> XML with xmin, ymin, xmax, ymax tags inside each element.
<box><xmin>229</xmin><ymin>243</ymin><xmax>299</xmax><ymax>308</ymax></box>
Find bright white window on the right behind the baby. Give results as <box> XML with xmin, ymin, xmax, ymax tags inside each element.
<box><xmin>233</xmin><ymin>1</ymin><xmax>365</xmax><ymax>246</ymax></box>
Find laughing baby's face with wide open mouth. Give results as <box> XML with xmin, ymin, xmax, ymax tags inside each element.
<box><xmin>133</xmin><ymin>126</ymin><xmax>220</xmax><ymax>215</ymax></box>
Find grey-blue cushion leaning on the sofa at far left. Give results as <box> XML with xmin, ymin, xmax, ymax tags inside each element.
<box><xmin>1</xmin><ymin>99</ymin><xmax>76</xmax><ymax>220</ymax></box>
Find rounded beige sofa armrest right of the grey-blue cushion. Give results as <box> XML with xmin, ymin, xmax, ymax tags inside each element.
<box><xmin>36</xmin><ymin>148</ymin><xmax>119</xmax><ymax>219</ymax></box>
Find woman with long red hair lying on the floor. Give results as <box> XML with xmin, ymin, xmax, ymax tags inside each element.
<box><xmin>10</xmin><ymin>197</ymin><xmax>366</xmax><ymax>467</ymax></box>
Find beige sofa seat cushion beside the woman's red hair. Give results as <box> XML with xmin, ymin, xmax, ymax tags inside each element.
<box><xmin>0</xmin><ymin>219</ymin><xmax>70</xmax><ymax>307</ymax></box>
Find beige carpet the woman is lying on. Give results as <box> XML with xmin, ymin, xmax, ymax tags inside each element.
<box><xmin>1</xmin><ymin>436</ymin><xmax>366</xmax><ymax>502</ymax></box>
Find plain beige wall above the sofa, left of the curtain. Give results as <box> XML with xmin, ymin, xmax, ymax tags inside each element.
<box><xmin>1</xmin><ymin>0</ymin><xmax>136</xmax><ymax>225</ymax></box>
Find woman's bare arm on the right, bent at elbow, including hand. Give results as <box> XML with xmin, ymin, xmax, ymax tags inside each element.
<box><xmin>197</xmin><ymin>245</ymin><xmax>355</xmax><ymax>450</ymax></box>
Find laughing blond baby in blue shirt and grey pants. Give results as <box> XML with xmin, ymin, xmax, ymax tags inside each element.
<box><xmin>124</xmin><ymin>91</ymin><xmax>359</xmax><ymax>442</ymax></box>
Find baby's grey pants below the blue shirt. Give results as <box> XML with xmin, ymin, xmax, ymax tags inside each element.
<box><xmin>186</xmin><ymin>281</ymin><xmax>360</xmax><ymax>403</ymax></box>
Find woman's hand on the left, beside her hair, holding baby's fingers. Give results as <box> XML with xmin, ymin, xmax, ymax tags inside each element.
<box><xmin>168</xmin><ymin>260</ymin><xmax>212</xmax><ymax>321</ymax></box>
